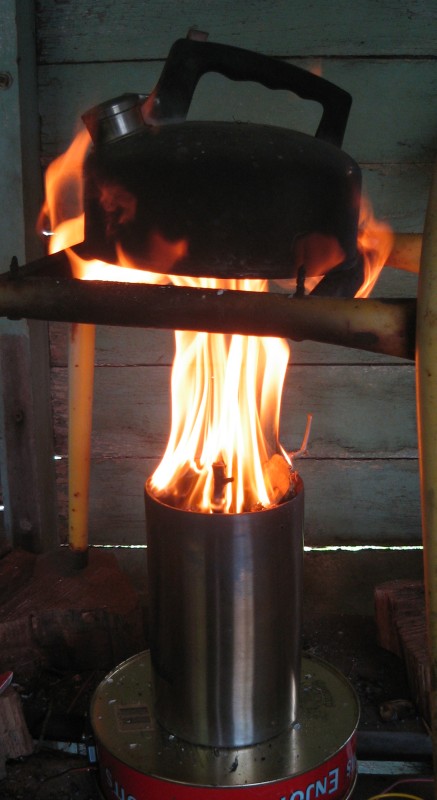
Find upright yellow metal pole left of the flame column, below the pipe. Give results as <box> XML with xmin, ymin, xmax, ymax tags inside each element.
<box><xmin>68</xmin><ymin>323</ymin><xmax>96</xmax><ymax>567</ymax></box>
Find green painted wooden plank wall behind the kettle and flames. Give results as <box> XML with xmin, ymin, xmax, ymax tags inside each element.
<box><xmin>37</xmin><ymin>0</ymin><xmax>437</xmax><ymax>546</ymax></box>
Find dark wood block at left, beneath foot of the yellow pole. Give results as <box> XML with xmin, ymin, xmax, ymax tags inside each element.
<box><xmin>0</xmin><ymin>548</ymin><xmax>145</xmax><ymax>681</ymax></box>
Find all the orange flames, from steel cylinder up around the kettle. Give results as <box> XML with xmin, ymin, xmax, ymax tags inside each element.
<box><xmin>39</xmin><ymin>125</ymin><xmax>391</xmax><ymax>513</ymax></box>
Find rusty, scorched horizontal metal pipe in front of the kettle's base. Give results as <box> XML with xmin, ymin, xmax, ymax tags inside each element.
<box><xmin>0</xmin><ymin>278</ymin><xmax>416</xmax><ymax>359</ymax></box>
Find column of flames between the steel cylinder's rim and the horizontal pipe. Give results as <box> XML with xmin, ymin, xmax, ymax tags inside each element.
<box><xmin>151</xmin><ymin>296</ymin><xmax>289</xmax><ymax>513</ymax></box>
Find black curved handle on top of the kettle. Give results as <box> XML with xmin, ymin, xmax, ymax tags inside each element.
<box><xmin>143</xmin><ymin>39</ymin><xmax>352</xmax><ymax>147</ymax></box>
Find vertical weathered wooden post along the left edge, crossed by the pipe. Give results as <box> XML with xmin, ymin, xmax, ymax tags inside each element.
<box><xmin>0</xmin><ymin>0</ymin><xmax>56</xmax><ymax>550</ymax></box>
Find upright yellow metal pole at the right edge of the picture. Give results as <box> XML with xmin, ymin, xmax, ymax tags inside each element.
<box><xmin>416</xmin><ymin>158</ymin><xmax>437</xmax><ymax>786</ymax></box>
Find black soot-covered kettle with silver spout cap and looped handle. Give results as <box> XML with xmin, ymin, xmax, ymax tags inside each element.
<box><xmin>75</xmin><ymin>39</ymin><xmax>362</xmax><ymax>296</ymax></box>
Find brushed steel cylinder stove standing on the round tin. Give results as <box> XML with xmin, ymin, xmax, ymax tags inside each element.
<box><xmin>145</xmin><ymin>481</ymin><xmax>303</xmax><ymax>747</ymax></box>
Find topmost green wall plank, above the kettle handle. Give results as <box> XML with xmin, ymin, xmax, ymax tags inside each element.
<box><xmin>38</xmin><ymin>0</ymin><xmax>437</xmax><ymax>63</ymax></box>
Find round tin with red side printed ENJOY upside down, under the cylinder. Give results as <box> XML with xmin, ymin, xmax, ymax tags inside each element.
<box><xmin>91</xmin><ymin>652</ymin><xmax>359</xmax><ymax>800</ymax></box>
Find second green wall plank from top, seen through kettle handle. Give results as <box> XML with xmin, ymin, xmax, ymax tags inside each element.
<box><xmin>39</xmin><ymin>58</ymin><xmax>437</xmax><ymax>165</ymax></box>
